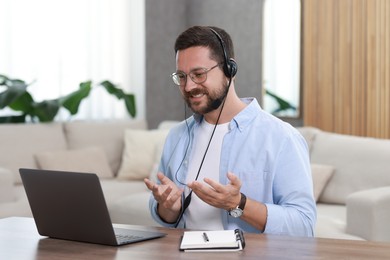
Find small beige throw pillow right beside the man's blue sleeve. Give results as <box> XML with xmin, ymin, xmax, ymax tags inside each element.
<box><xmin>311</xmin><ymin>163</ymin><xmax>334</xmax><ymax>202</ymax></box>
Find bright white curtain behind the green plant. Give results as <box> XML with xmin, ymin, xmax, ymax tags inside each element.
<box><xmin>0</xmin><ymin>0</ymin><xmax>145</xmax><ymax>120</ymax></box>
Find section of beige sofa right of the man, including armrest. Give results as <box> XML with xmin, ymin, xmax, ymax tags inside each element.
<box><xmin>298</xmin><ymin>127</ymin><xmax>390</xmax><ymax>241</ymax></box>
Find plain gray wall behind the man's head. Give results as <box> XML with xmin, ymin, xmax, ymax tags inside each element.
<box><xmin>145</xmin><ymin>0</ymin><xmax>263</xmax><ymax>128</ymax></box>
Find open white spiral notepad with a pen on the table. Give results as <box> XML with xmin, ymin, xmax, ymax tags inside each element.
<box><xmin>180</xmin><ymin>229</ymin><xmax>245</xmax><ymax>252</ymax></box>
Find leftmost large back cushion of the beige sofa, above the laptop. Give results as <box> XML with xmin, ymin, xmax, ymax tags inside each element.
<box><xmin>0</xmin><ymin>123</ymin><xmax>67</xmax><ymax>184</ymax></box>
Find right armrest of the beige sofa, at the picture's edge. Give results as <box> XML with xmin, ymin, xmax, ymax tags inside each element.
<box><xmin>346</xmin><ymin>186</ymin><xmax>390</xmax><ymax>241</ymax></box>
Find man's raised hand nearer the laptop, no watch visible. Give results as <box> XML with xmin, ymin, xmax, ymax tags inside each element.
<box><xmin>144</xmin><ymin>172</ymin><xmax>183</xmax><ymax>223</ymax></box>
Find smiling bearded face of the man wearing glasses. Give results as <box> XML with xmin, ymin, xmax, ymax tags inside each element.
<box><xmin>176</xmin><ymin>47</ymin><xmax>227</xmax><ymax>115</ymax></box>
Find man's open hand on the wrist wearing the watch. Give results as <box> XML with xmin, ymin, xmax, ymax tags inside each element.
<box><xmin>188</xmin><ymin>172</ymin><xmax>241</xmax><ymax>210</ymax></box>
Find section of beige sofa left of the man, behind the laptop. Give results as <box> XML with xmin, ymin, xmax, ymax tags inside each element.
<box><xmin>0</xmin><ymin>120</ymin><xmax>165</xmax><ymax>225</ymax></box>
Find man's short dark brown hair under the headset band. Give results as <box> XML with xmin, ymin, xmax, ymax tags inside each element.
<box><xmin>175</xmin><ymin>26</ymin><xmax>234</xmax><ymax>64</ymax></box>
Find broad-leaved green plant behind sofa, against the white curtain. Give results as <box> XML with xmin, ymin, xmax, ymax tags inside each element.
<box><xmin>0</xmin><ymin>75</ymin><xmax>136</xmax><ymax>123</ymax></box>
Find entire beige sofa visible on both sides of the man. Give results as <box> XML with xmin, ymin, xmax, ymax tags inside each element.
<box><xmin>0</xmin><ymin>121</ymin><xmax>390</xmax><ymax>241</ymax></box>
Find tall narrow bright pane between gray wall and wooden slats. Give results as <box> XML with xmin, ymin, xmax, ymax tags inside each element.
<box><xmin>263</xmin><ymin>0</ymin><xmax>301</xmax><ymax>117</ymax></box>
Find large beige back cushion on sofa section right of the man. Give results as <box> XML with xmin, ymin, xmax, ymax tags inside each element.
<box><xmin>311</xmin><ymin>131</ymin><xmax>390</xmax><ymax>204</ymax></box>
